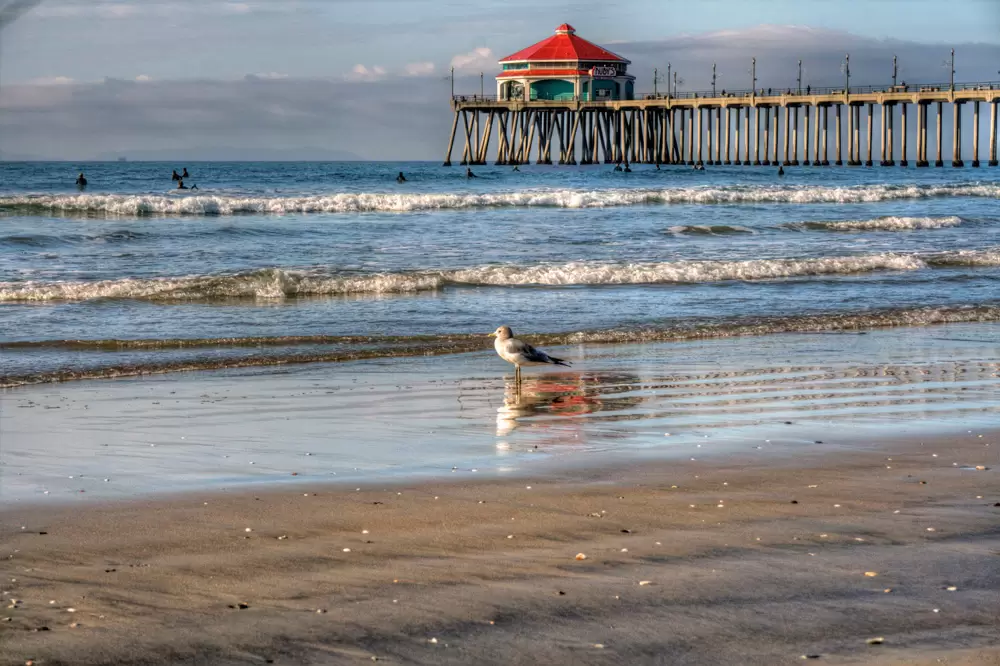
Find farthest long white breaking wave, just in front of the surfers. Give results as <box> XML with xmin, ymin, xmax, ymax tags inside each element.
<box><xmin>0</xmin><ymin>182</ymin><xmax>1000</xmax><ymax>216</ymax></box>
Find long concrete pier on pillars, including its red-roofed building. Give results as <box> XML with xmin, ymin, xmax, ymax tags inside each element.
<box><xmin>444</xmin><ymin>24</ymin><xmax>1000</xmax><ymax>167</ymax></box>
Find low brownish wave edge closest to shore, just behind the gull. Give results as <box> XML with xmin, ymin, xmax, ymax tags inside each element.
<box><xmin>0</xmin><ymin>304</ymin><xmax>1000</xmax><ymax>388</ymax></box>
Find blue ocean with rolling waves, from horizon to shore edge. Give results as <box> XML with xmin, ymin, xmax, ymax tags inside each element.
<box><xmin>0</xmin><ymin>162</ymin><xmax>1000</xmax><ymax>387</ymax></box>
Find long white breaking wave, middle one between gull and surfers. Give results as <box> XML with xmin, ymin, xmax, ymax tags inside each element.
<box><xmin>0</xmin><ymin>248</ymin><xmax>1000</xmax><ymax>302</ymax></box>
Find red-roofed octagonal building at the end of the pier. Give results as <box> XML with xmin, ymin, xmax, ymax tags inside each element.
<box><xmin>497</xmin><ymin>23</ymin><xmax>635</xmax><ymax>102</ymax></box>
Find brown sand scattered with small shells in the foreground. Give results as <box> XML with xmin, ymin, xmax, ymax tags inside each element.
<box><xmin>0</xmin><ymin>428</ymin><xmax>1000</xmax><ymax>665</ymax></box>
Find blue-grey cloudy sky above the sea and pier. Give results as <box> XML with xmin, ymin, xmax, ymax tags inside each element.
<box><xmin>0</xmin><ymin>0</ymin><xmax>1000</xmax><ymax>159</ymax></box>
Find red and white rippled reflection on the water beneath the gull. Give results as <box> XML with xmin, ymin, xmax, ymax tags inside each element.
<box><xmin>497</xmin><ymin>373</ymin><xmax>643</xmax><ymax>436</ymax></box>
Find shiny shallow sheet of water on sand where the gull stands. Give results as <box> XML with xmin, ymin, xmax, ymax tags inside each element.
<box><xmin>0</xmin><ymin>323</ymin><xmax>1000</xmax><ymax>502</ymax></box>
